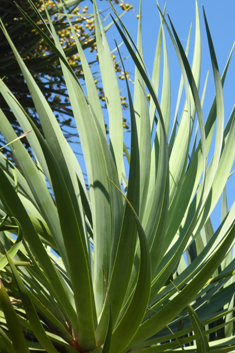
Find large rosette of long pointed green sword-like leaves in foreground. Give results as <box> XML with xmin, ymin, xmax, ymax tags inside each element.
<box><xmin>0</xmin><ymin>1</ymin><xmax>235</xmax><ymax>353</ymax></box>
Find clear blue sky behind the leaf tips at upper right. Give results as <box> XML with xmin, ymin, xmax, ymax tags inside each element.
<box><xmin>81</xmin><ymin>0</ymin><xmax>235</xmax><ymax>228</ymax></box>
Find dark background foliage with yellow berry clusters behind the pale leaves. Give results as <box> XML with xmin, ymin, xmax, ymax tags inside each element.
<box><xmin>0</xmin><ymin>0</ymin><xmax>133</xmax><ymax>160</ymax></box>
